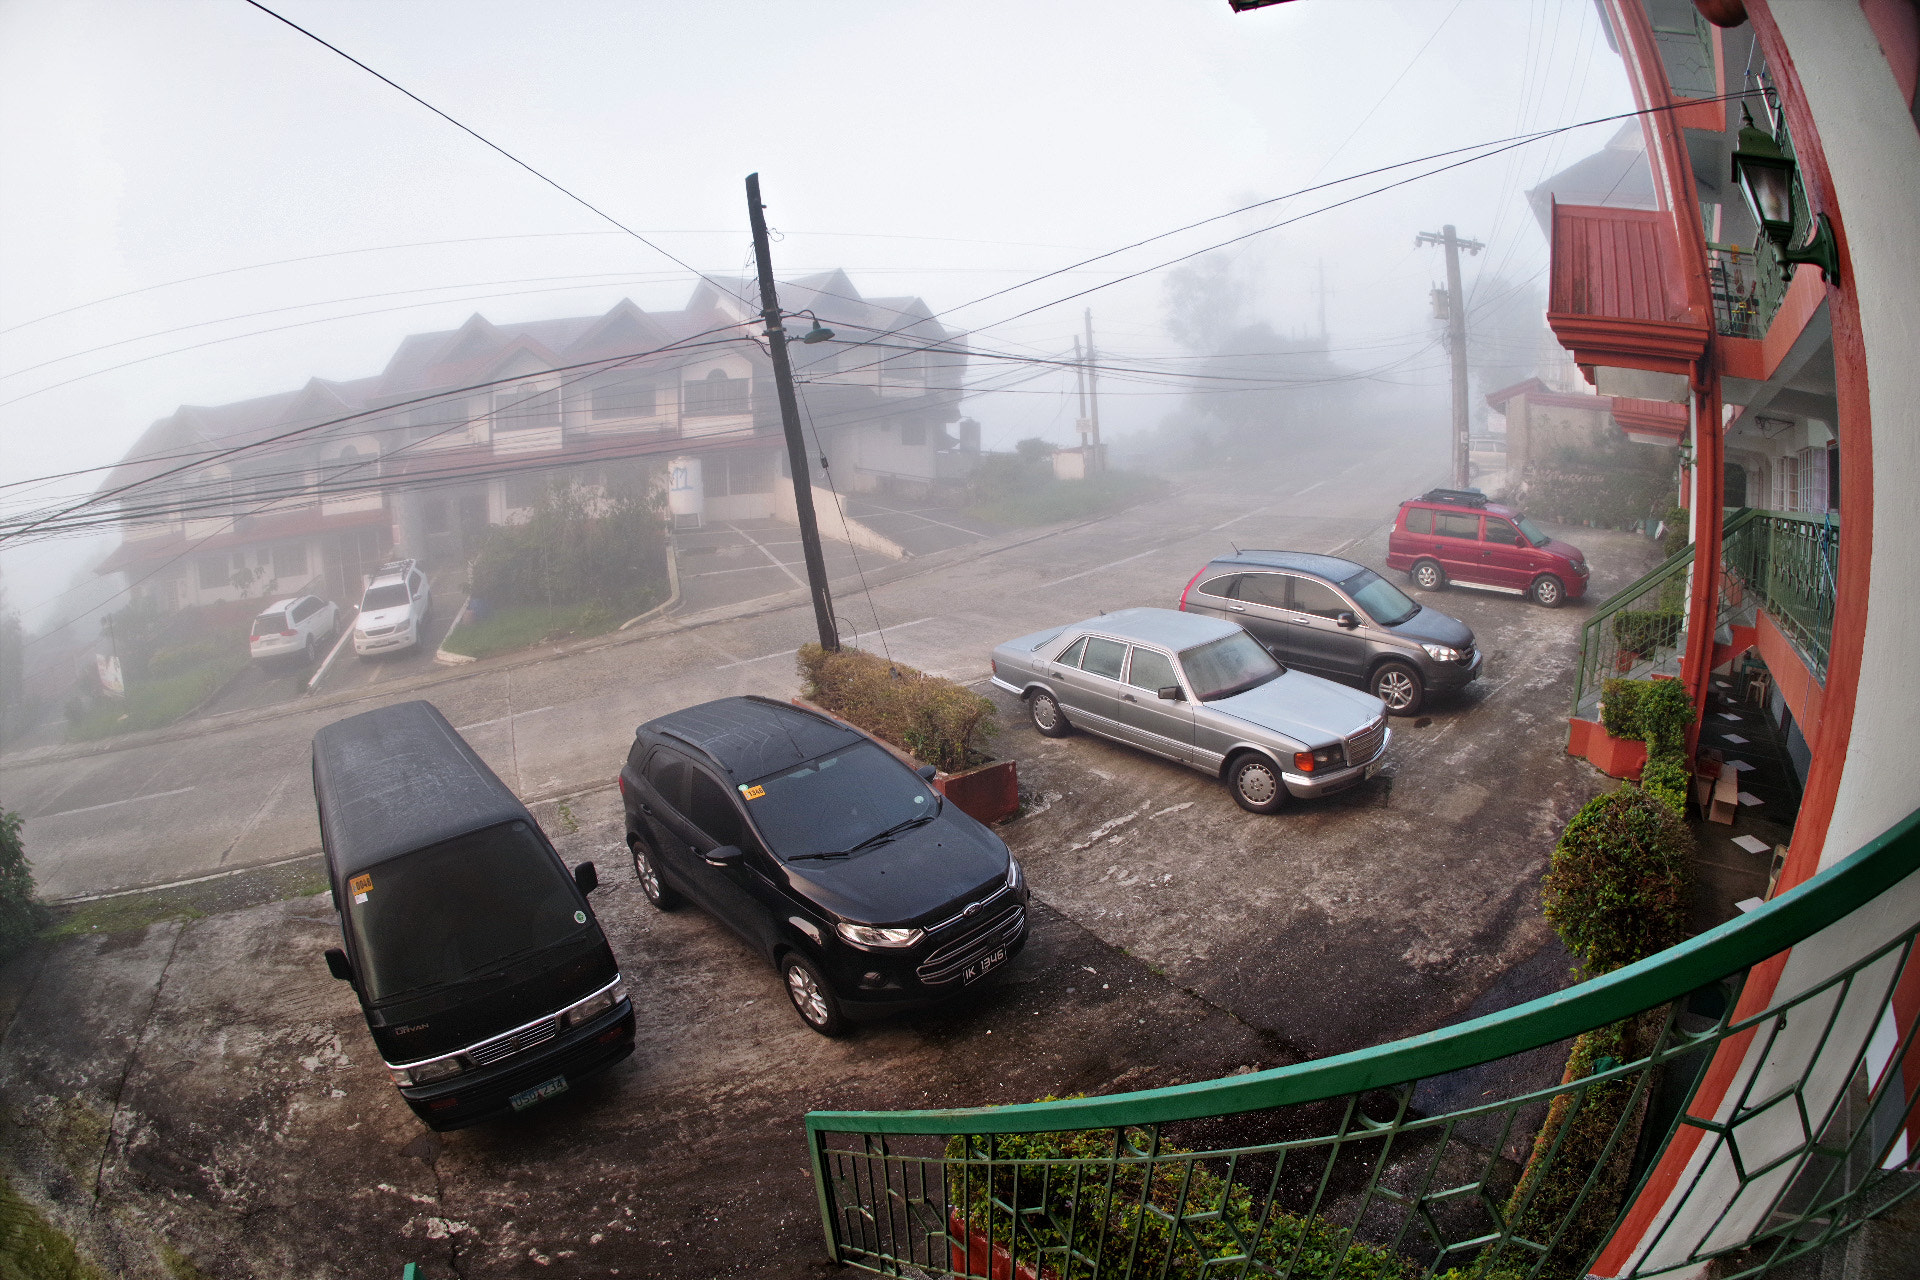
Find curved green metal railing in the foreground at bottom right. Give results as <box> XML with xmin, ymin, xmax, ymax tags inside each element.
<box><xmin>806</xmin><ymin>814</ymin><xmax>1920</xmax><ymax>1280</ymax></box>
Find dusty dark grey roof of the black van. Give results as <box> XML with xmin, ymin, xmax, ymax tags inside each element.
<box><xmin>313</xmin><ymin>700</ymin><xmax>534</xmax><ymax>877</ymax></box>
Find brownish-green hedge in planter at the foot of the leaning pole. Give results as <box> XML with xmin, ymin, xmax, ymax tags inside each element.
<box><xmin>801</xmin><ymin>645</ymin><xmax>1000</xmax><ymax>773</ymax></box>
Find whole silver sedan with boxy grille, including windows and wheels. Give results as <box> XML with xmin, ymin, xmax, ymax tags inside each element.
<box><xmin>993</xmin><ymin>608</ymin><xmax>1392</xmax><ymax>814</ymax></box>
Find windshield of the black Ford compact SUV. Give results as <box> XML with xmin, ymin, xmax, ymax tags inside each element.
<box><xmin>741</xmin><ymin>743</ymin><xmax>937</xmax><ymax>860</ymax></box>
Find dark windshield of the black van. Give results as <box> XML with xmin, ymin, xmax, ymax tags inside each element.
<box><xmin>346</xmin><ymin>821</ymin><xmax>591</xmax><ymax>1002</ymax></box>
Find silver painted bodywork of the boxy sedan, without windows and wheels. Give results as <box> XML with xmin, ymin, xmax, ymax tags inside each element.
<box><xmin>993</xmin><ymin>608</ymin><xmax>1392</xmax><ymax>798</ymax></box>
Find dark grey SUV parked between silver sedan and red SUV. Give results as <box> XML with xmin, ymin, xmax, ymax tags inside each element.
<box><xmin>1181</xmin><ymin>551</ymin><xmax>1480</xmax><ymax>716</ymax></box>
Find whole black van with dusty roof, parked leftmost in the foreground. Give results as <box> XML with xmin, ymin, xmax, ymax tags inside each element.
<box><xmin>313</xmin><ymin>702</ymin><xmax>634</xmax><ymax>1130</ymax></box>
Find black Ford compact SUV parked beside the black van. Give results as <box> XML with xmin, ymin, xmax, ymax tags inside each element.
<box><xmin>620</xmin><ymin>697</ymin><xmax>1027</xmax><ymax>1036</ymax></box>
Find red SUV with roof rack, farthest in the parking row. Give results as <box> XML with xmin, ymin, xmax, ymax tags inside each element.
<box><xmin>1386</xmin><ymin>489</ymin><xmax>1588</xmax><ymax>608</ymax></box>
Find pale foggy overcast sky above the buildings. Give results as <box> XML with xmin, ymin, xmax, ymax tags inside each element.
<box><xmin>0</xmin><ymin>0</ymin><xmax>1632</xmax><ymax>610</ymax></box>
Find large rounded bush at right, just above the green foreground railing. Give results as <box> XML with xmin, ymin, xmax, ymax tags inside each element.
<box><xmin>1544</xmin><ymin>783</ymin><xmax>1693</xmax><ymax>975</ymax></box>
